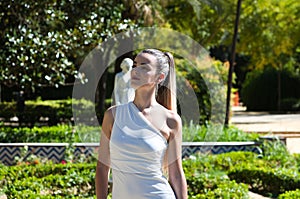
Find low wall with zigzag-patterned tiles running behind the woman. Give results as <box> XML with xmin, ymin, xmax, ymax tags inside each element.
<box><xmin>0</xmin><ymin>142</ymin><xmax>261</xmax><ymax>165</ymax></box>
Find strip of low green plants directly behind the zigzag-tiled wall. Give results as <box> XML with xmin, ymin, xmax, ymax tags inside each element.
<box><xmin>0</xmin><ymin>124</ymin><xmax>259</xmax><ymax>143</ymax></box>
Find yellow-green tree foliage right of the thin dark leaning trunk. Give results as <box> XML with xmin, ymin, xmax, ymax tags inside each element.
<box><xmin>237</xmin><ymin>0</ymin><xmax>300</xmax><ymax>68</ymax></box>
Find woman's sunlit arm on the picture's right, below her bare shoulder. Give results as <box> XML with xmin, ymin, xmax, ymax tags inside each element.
<box><xmin>167</xmin><ymin>115</ymin><xmax>187</xmax><ymax>199</ymax></box>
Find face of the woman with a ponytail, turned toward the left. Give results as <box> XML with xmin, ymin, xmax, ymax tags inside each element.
<box><xmin>131</xmin><ymin>53</ymin><xmax>158</xmax><ymax>89</ymax></box>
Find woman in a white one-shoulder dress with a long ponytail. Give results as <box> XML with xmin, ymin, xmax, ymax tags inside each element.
<box><xmin>96</xmin><ymin>49</ymin><xmax>187</xmax><ymax>199</ymax></box>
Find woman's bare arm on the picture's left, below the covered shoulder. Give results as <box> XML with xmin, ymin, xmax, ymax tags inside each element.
<box><xmin>95</xmin><ymin>109</ymin><xmax>113</xmax><ymax>199</ymax></box>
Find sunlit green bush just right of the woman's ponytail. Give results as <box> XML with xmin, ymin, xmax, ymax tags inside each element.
<box><xmin>176</xmin><ymin>60</ymin><xmax>227</xmax><ymax>124</ymax></box>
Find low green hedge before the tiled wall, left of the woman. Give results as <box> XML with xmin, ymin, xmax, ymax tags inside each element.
<box><xmin>0</xmin><ymin>163</ymin><xmax>96</xmax><ymax>198</ymax></box>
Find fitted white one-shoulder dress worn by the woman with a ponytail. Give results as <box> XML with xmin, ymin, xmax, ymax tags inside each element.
<box><xmin>110</xmin><ymin>102</ymin><xmax>175</xmax><ymax>199</ymax></box>
